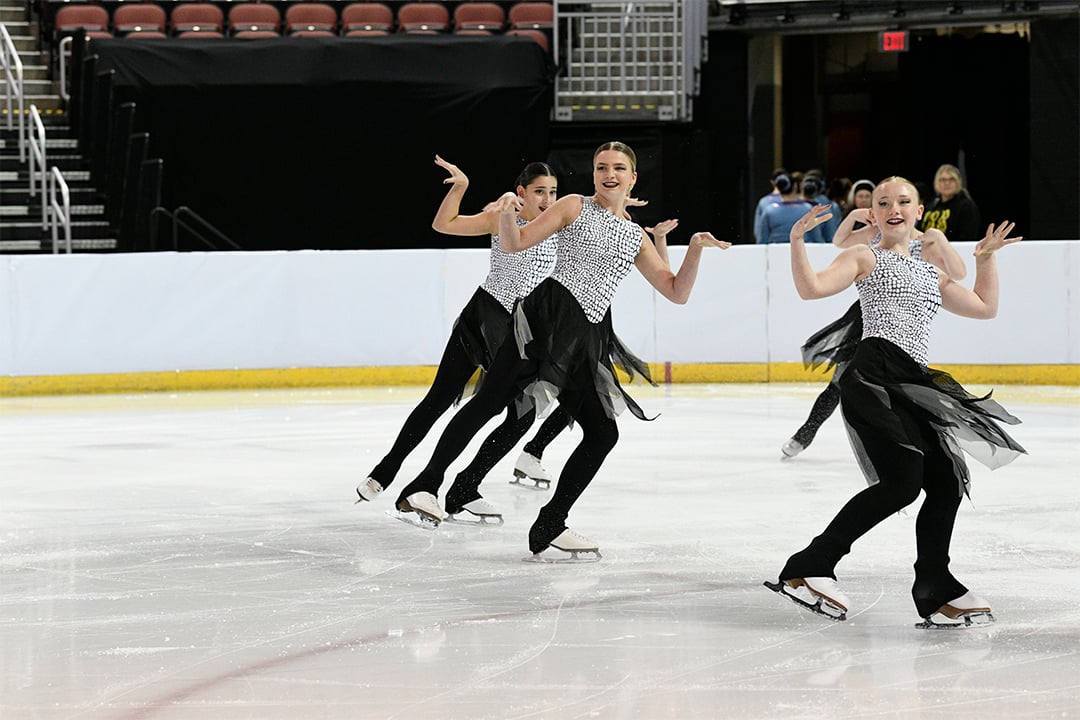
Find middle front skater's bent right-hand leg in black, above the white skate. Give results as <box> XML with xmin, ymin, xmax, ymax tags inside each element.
<box><xmin>529</xmin><ymin>385</ymin><xmax>619</xmax><ymax>553</ymax></box>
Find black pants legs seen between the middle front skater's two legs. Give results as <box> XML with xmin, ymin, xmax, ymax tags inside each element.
<box><xmin>446</xmin><ymin>404</ymin><xmax>570</xmax><ymax>514</ymax></box>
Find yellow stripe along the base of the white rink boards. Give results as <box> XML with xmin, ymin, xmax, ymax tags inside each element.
<box><xmin>0</xmin><ymin>363</ymin><xmax>1080</xmax><ymax>397</ymax></box>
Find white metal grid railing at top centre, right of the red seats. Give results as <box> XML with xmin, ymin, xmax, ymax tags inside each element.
<box><xmin>554</xmin><ymin>0</ymin><xmax>708</xmax><ymax>121</ymax></box>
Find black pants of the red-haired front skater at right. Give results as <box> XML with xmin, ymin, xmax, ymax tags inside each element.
<box><xmin>780</xmin><ymin>377</ymin><xmax>967</xmax><ymax>617</ymax></box>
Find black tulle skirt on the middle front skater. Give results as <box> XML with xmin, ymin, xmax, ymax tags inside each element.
<box><xmin>513</xmin><ymin>277</ymin><xmax>656</xmax><ymax>420</ymax></box>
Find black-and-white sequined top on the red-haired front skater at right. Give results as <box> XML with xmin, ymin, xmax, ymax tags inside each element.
<box><xmin>855</xmin><ymin>246</ymin><xmax>942</xmax><ymax>367</ymax></box>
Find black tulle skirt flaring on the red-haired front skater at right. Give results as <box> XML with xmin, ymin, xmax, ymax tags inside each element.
<box><xmin>839</xmin><ymin>338</ymin><xmax>1027</xmax><ymax>493</ymax></box>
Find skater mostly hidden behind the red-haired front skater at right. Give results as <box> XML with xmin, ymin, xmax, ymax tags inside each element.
<box><xmin>780</xmin><ymin>197</ymin><xmax>968</xmax><ymax>460</ymax></box>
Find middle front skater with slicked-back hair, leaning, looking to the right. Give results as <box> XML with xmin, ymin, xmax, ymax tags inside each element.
<box><xmin>397</xmin><ymin>142</ymin><xmax>730</xmax><ymax>560</ymax></box>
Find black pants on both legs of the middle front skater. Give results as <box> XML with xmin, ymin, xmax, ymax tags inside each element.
<box><xmin>399</xmin><ymin>332</ymin><xmax>619</xmax><ymax>553</ymax></box>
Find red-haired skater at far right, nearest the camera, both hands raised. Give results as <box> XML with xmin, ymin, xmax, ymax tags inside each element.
<box><xmin>766</xmin><ymin>177</ymin><xmax>1025</xmax><ymax>626</ymax></box>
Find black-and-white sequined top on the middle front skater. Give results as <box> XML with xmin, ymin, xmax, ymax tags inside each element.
<box><xmin>551</xmin><ymin>198</ymin><xmax>642</xmax><ymax>324</ymax></box>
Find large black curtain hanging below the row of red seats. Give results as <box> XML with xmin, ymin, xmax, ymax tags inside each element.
<box><xmin>88</xmin><ymin>37</ymin><xmax>552</xmax><ymax>249</ymax></box>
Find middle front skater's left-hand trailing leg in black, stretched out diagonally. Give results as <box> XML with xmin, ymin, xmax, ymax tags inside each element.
<box><xmin>397</xmin><ymin>342</ymin><xmax>536</xmax><ymax>506</ymax></box>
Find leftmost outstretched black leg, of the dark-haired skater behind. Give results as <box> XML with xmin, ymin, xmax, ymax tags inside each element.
<box><xmin>368</xmin><ymin>332</ymin><xmax>476</xmax><ymax>489</ymax></box>
